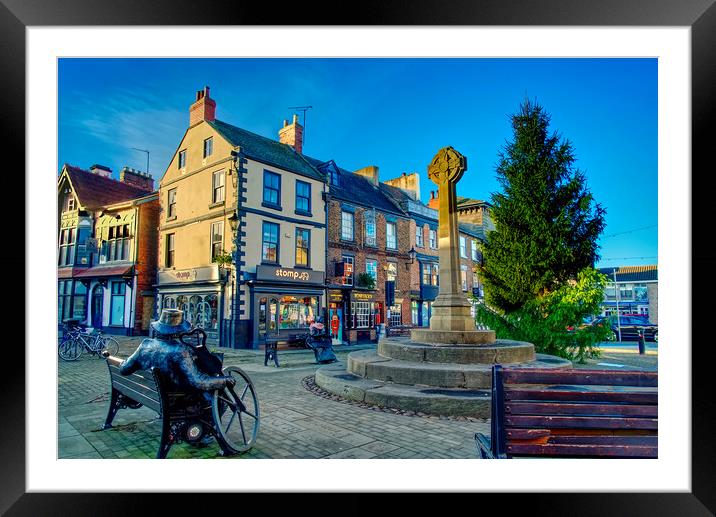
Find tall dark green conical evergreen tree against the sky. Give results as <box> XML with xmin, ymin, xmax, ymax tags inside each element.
<box><xmin>480</xmin><ymin>100</ymin><xmax>605</xmax><ymax>312</ymax></box>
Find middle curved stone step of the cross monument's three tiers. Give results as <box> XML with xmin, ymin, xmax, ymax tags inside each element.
<box><xmin>347</xmin><ymin>350</ymin><xmax>572</xmax><ymax>389</ymax></box>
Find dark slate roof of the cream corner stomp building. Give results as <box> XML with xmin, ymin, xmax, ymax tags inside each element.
<box><xmin>206</xmin><ymin>119</ymin><xmax>325</xmax><ymax>181</ymax></box>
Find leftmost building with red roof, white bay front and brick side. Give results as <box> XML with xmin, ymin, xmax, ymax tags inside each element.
<box><xmin>57</xmin><ymin>164</ymin><xmax>159</xmax><ymax>335</ymax></box>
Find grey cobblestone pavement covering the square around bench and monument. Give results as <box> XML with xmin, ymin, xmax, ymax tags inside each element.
<box><xmin>58</xmin><ymin>337</ymin><xmax>656</xmax><ymax>459</ymax></box>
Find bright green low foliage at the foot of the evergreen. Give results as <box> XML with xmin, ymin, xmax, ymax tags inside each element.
<box><xmin>476</xmin><ymin>268</ymin><xmax>611</xmax><ymax>362</ymax></box>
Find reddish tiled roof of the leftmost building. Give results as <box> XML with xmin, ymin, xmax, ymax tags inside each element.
<box><xmin>64</xmin><ymin>164</ymin><xmax>152</xmax><ymax>208</ymax></box>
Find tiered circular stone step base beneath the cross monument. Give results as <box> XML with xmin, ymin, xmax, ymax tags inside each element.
<box><xmin>316</xmin><ymin>329</ymin><xmax>572</xmax><ymax>418</ymax></box>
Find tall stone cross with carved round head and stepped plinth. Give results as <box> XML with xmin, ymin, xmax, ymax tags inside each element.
<box><xmin>411</xmin><ymin>147</ymin><xmax>495</xmax><ymax>344</ymax></box>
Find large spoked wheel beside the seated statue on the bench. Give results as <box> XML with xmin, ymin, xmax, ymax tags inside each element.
<box><xmin>211</xmin><ymin>366</ymin><xmax>259</xmax><ymax>454</ymax></box>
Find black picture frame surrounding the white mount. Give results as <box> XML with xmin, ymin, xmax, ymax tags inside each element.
<box><xmin>7</xmin><ymin>0</ymin><xmax>716</xmax><ymax>516</ymax></box>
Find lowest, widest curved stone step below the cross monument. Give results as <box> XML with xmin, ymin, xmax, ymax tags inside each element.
<box><xmin>316</xmin><ymin>360</ymin><xmax>490</xmax><ymax>418</ymax></box>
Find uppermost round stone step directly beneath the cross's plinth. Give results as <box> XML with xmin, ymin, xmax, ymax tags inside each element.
<box><xmin>378</xmin><ymin>338</ymin><xmax>536</xmax><ymax>365</ymax></box>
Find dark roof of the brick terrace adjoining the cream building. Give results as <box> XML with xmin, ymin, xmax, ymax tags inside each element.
<box><xmin>304</xmin><ymin>156</ymin><xmax>405</xmax><ymax>216</ymax></box>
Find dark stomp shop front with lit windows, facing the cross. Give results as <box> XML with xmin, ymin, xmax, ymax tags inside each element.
<box><xmin>247</xmin><ymin>265</ymin><xmax>327</xmax><ymax>348</ymax></box>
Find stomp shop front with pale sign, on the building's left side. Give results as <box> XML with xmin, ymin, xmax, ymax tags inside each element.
<box><xmin>157</xmin><ymin>265</ymin><xmax>224</xmax><ymax>345</ymax></box>
